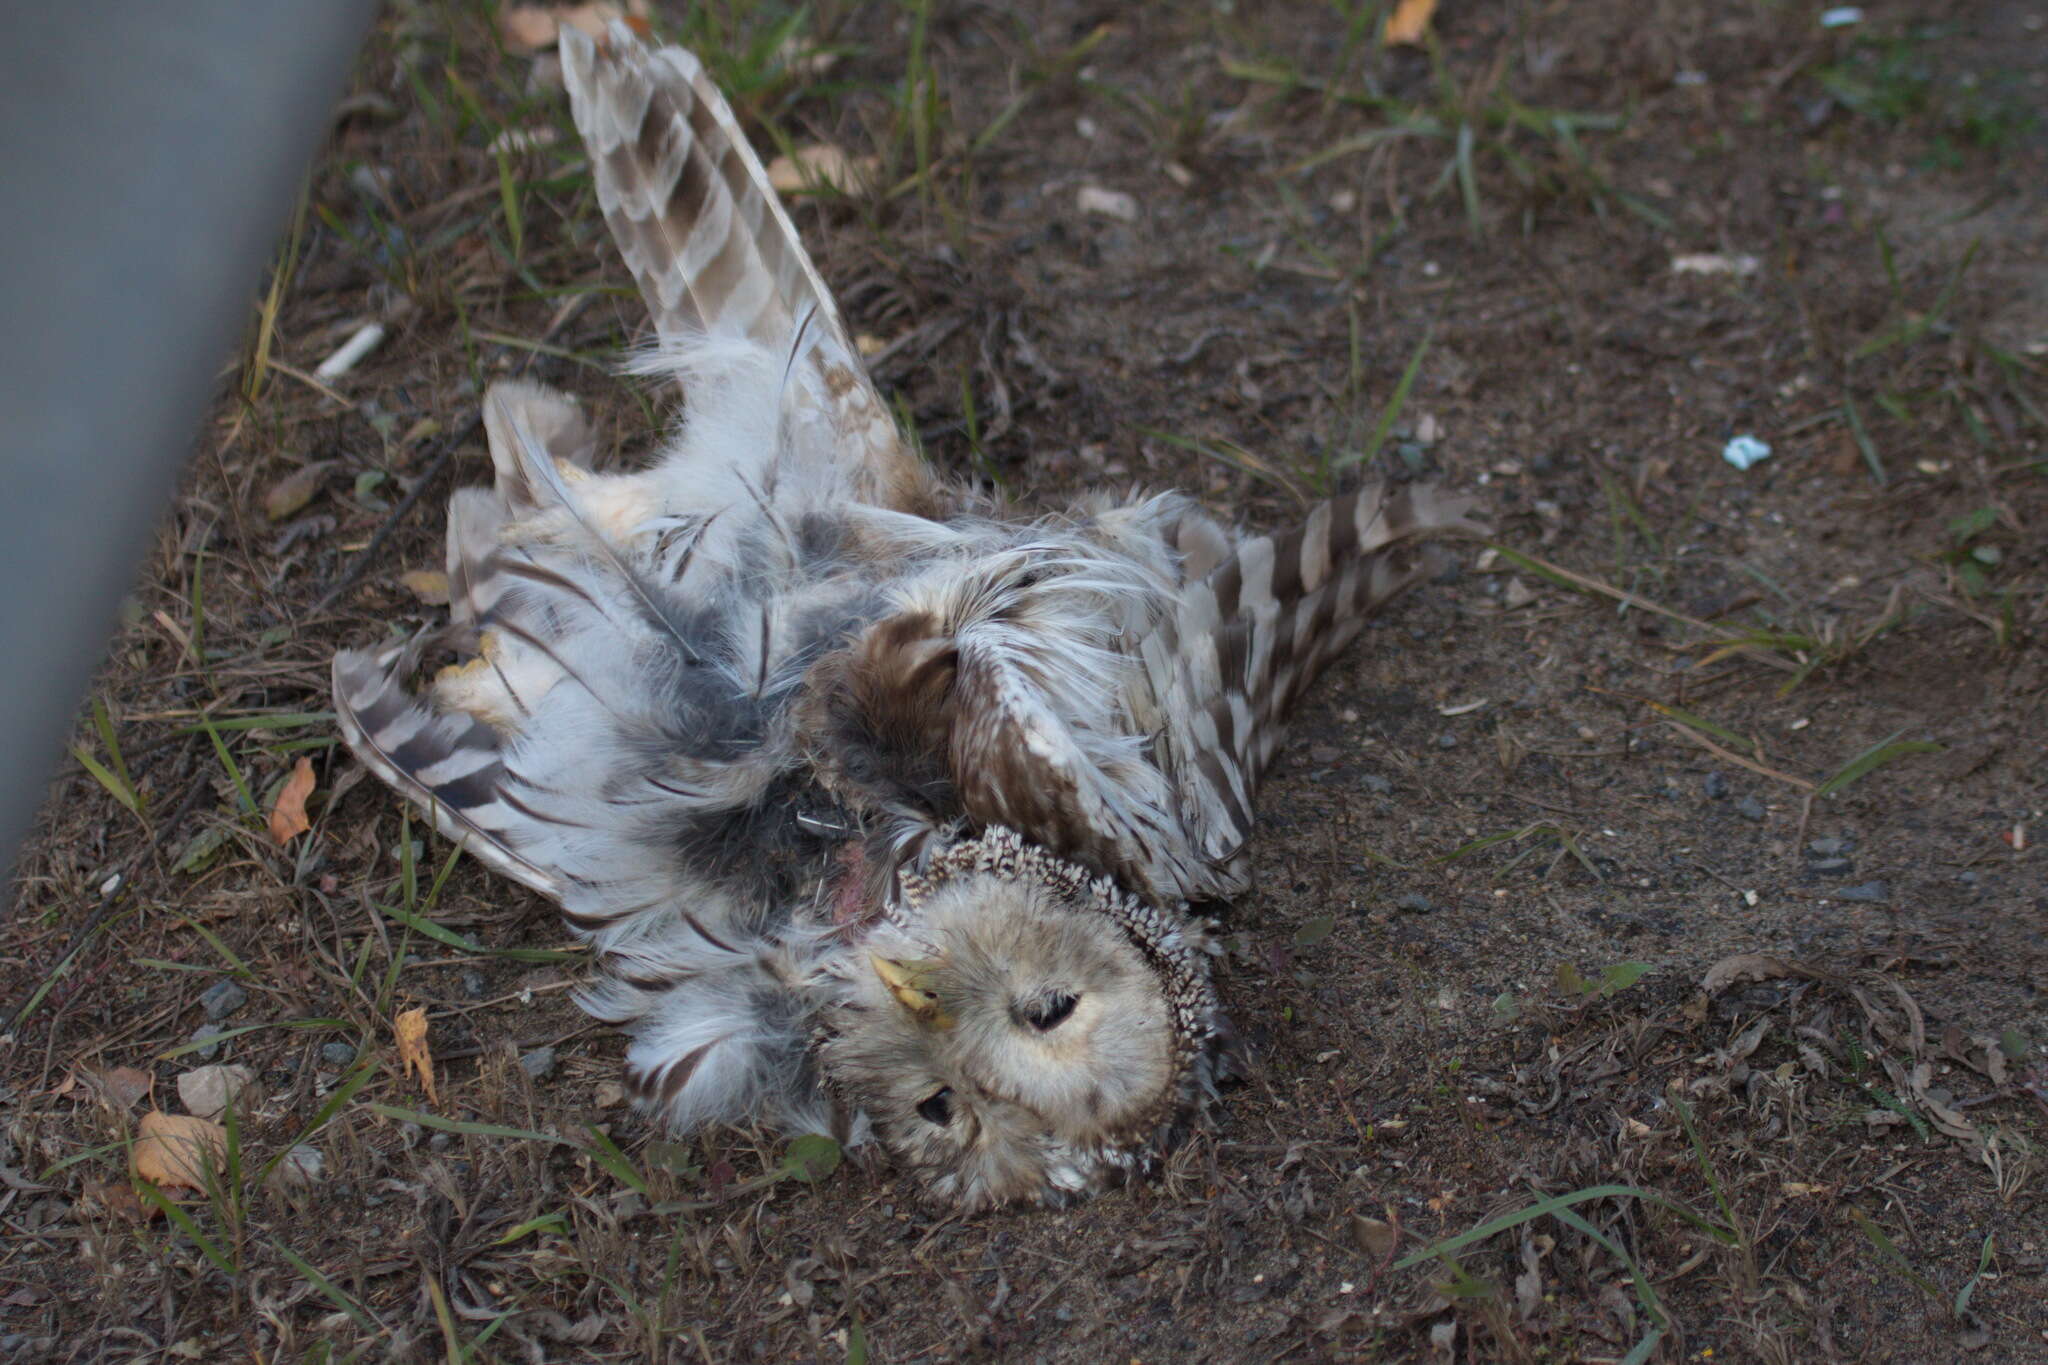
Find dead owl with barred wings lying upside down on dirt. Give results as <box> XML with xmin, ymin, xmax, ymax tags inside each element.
<box><xmin>334</xmin><ymin>27</ymin><xmax>1477</xmax><ymax>1207</ymax></box>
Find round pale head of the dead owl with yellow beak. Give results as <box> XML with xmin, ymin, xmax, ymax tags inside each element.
<box><xmin>819</xmin><ymin>829</ymin><xmax>1225</xmax><ymax>1209</ymax></box>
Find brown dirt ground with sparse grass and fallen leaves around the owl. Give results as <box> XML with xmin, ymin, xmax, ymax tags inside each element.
<box><xmin>0</xmin><ymin>0</ymin><xmax>2048</xmax><ymax>1361</ymax></box>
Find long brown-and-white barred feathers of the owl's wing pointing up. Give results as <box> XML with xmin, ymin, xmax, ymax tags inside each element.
<box><xmin>561</xmin><ymin>23</ymin><xmax>932</xmax><ymax>512</ymax></box>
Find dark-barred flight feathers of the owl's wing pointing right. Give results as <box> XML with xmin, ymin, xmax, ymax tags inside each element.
<box><xmin>1139</xmin><ymin>485</ymin><xmax>1485</xmax><ymax>894</ymax></box>
